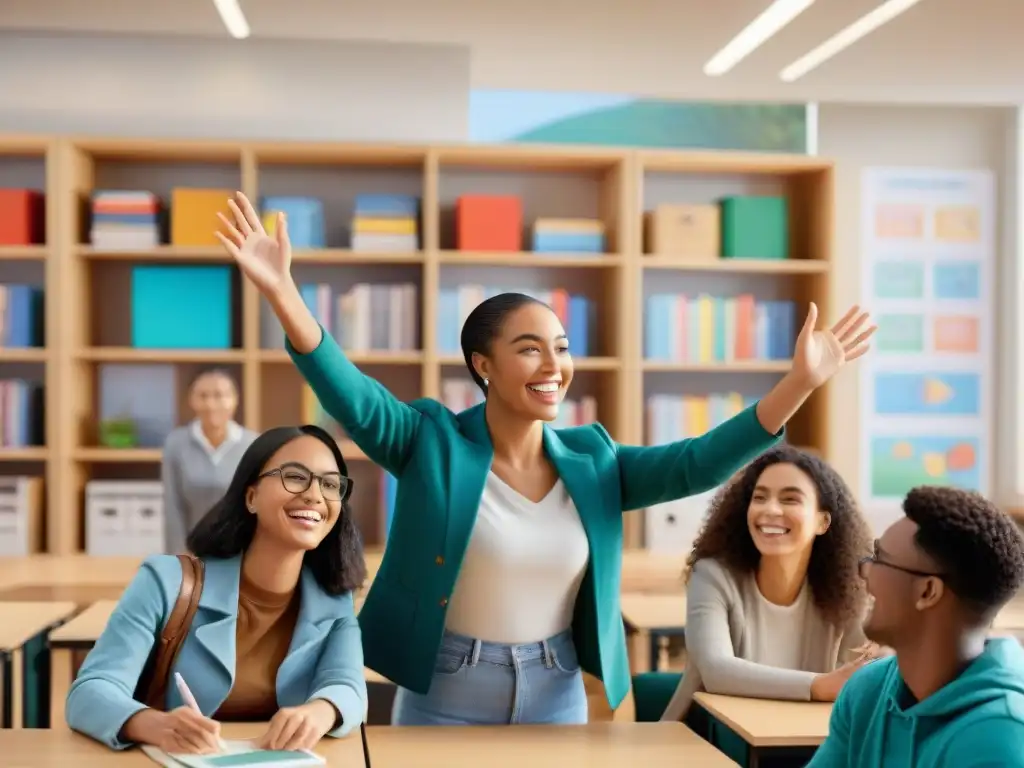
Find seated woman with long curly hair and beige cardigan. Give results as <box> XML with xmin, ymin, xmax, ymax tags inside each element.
<box><xmin>647</xmin><ymin>445</ymin><xmax>871</xmax><ymax>720</ymax></box>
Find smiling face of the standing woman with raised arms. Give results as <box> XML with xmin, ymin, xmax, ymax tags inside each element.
<box><xmin>473</xmin><ymin>303</ymin><xmax>572</xmax><ymax>421</ymax></box>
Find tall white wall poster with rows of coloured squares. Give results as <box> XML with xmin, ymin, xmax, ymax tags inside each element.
<box><xmin>860</xmin><ymin>168</ymin><xmax>995</xmax><ymax>511</ymax></box>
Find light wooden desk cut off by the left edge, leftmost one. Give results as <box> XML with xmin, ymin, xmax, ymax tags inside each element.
<box><xmin>0</xmin><ymin>602</ymin><xmax>75</xmax><ymax>728</ymax></box>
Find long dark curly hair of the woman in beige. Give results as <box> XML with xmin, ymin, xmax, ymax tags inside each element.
<box><xmin>686</xmin><ymin>445</ymin><xmax>872</xmax><ymax>627</ymax></box>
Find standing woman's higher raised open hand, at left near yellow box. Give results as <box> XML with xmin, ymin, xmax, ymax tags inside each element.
<box><xmin>216</xmin><ymin>193</ymin><xmax>292</xmax><ymax>296</ymax></box>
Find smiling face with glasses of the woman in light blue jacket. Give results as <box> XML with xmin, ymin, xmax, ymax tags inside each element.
<box><xmin>246</xmin><ymin>435</ymin><xmax>347</xmax><ymax>551</ymax></box>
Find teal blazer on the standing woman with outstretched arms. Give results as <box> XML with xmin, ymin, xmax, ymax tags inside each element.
<box><xmin>287</xmin><ymin>333</ymin><xmax>782</xmax><ymax>709</ymax></box>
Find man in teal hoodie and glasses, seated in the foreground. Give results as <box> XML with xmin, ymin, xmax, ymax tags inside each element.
<box><xmin>808</xmin><ymin>486</ymin><xmax>1024</xmax><ymax>768</ymax></box>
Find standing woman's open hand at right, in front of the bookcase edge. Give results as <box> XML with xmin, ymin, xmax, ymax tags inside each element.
<box><xmin>793</xmin><ymin>302</ymin><xmax>878</xmax><ymax>388</ymax></box>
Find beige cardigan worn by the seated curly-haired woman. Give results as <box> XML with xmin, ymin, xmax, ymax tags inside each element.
<box><xmin>662</xmin><ymin>559</ymin><xmax>865</xmax><ymax>720</ymax></box>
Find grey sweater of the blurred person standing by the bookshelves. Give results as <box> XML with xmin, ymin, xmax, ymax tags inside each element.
<box><xmin>161</xmin><ymin>423</ymin><xmax>257</xmax><ymax>554</ymax></box>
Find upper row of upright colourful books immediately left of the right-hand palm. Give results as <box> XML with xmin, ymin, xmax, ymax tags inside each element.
<box><xmin>644</xmin><ymin>294</ymin><xmax>797</xmax><ymax>364</ymax></box>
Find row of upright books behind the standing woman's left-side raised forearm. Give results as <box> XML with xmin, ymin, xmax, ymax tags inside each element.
<box><xmin>262</xmin><ymin>283</ymin><xmax>420</xmax><ymax>352</ymax></box>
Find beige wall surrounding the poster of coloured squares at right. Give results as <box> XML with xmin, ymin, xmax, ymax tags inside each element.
<box><xmin>818</xmin><ymin>104</ymin><xmax>1019</xmax><ymax>528</ymax></box>
